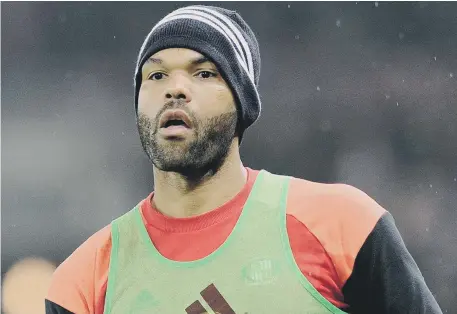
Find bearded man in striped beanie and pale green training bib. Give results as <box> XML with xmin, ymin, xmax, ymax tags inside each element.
<box><xmin>46</xmin><ymin>6</ymin><xmax>441</xmax><ymax>314</ymax></box>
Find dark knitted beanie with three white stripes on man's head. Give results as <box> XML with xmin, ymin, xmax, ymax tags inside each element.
<box><xmin>135</xmin><ymin>5</ymin><xmax>261</xmax><ymax>143</ymax></box>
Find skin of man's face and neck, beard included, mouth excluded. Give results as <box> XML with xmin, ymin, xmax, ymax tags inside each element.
<box><xmin>138</xmin><ymin>48</ymin><xmax>247</xmax><ymax>218</ymax></box>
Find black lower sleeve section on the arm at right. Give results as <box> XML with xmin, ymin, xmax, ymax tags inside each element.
<box><xmin>342</xmin><ymin>212</ymin><xmax>442</xmax><ymax>314</ymax></box>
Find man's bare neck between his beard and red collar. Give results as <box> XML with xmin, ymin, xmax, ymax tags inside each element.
<box><xmin>151</xmin><ymin>140</ymin><xmax>247</xmax><ymax>218</ymax></box>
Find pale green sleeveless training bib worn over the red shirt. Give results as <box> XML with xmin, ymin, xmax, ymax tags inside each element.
<box><xmin>104</xmin><ymin>170</ymin><xmax>344</xmax><ymax>314</ymax></box>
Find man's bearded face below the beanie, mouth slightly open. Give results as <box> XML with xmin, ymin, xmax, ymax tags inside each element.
<box><xmin>138</xmin><ymin>48</ymin><xmax>237</xmax><ymax>175</ymax></box>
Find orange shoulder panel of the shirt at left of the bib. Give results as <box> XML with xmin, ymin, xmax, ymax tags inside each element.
<box><xmin>46</xmin><ymin>224</ymin><xmax>111</xmax><ymax>313</ymax></box>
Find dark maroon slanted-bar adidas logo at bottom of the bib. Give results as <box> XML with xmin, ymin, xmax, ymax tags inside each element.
<box><xmin>186</xmin><ymin>284</ymin><xmax>235</xmax><ymax>314</ymax></box>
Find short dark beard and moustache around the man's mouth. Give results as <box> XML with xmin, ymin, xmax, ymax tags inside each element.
<box><xmin>138</xmin><ymin>102</ymin><xmax>238</xmax><ymax>180</ymax></box>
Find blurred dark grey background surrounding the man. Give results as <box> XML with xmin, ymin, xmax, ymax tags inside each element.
<box><xmin>1</xmin><ymin>2</ymin><xmax>457</xmax><ymax>314</ymax></box>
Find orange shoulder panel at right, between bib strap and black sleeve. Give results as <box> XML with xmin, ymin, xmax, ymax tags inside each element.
<box><xmin>287</xmin><ymin>177</ymin><xmax>387</xmax><ymax>284</ymax></box>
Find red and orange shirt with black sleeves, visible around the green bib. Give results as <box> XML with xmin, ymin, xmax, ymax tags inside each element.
<box><xmin>46</xmin><ymin>168</ymin><xmax>441</xmax><ymax>314</ymax></box>
